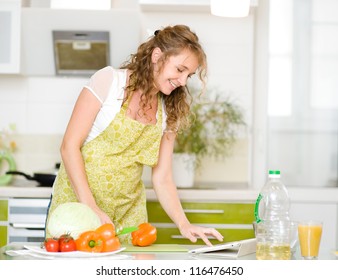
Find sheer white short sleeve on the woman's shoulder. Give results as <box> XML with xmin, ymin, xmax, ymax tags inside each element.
<box><xmin>85</xmin><ymin>66</ymin><xmax>114</xmax><ymax>103</ymax></box>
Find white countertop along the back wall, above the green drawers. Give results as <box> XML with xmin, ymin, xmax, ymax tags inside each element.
<box><xmin>0</xmin><ymin>181</ymin><xmax>338</xmax><ymax>203</ymax></box>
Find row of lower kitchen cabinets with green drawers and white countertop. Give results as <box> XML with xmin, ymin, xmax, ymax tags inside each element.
<box><xmin>0</xmin><ymin>186</ymin><xmax>338</xmax><ymax>249</ymax></box>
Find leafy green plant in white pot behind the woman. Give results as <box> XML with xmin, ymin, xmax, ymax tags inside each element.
<box><xmin>173</xmin><ymin>89</ymin><xmax>245</xmax><ymax>187</ymax></box>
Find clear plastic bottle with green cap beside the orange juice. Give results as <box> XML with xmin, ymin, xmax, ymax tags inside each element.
<box><xmin>255</xmin><ymin>170</ymin><xmax>291</xmax><ymax>260</ymax></box>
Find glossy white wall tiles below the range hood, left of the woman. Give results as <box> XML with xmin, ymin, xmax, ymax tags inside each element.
<box><xmin>0</xmin><ymin>76</ymin><xmax>87</xmax><ymax>134</ymax></box>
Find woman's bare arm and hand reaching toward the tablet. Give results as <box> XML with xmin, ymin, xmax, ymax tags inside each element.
<box><xmin>152</xmin><ymin>132</ymin><xmax>223</xmax><ymax>245</ymax></box>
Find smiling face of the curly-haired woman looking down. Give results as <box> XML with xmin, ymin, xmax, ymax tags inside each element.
<box><xmin>154</xmin><ymin>50</ymin><xmax>199</xmax><ymax>95</ymax></box>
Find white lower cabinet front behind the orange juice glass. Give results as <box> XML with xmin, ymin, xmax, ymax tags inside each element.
<box><xmin>290</xmin><ymin>203</ymin><xmax>338</xmax><ymax>249</ymax></box>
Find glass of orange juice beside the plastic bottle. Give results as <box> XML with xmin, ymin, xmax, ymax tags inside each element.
<box><xmin>298</xmin><ymin>221</ymin><xmax>323</xmax><ymax>260</ymax></box>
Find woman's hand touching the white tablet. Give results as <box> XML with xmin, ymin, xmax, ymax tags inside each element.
<box><xmin>180</xmin><ymin>223</ymin><xmax>223</xmax><ymax>246</ymax></box>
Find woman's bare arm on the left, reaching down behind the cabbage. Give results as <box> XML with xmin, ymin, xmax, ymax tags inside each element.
<box><xmin>61</xmin><ymin>88</ymin><xmax>112</xmax><ymax>223</ymax></box>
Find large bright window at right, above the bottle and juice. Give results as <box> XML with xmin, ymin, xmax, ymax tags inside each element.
<box><xmin>267</xmin><ymin>0</ymin><xmax>338</xmax><ymax>187</ymax></box>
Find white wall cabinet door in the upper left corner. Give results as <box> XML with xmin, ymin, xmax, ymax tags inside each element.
<box><xmin>0</xmin><ymin>0</ymin><xmax>21</xmax><ymax>74</ymax></box>
